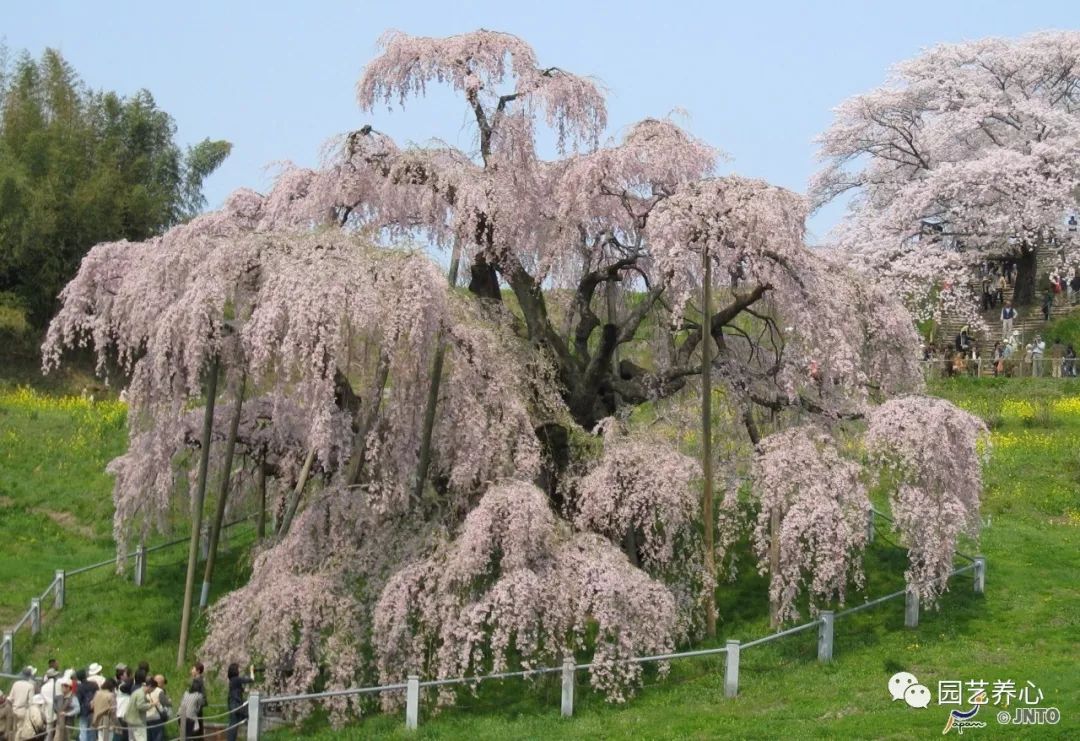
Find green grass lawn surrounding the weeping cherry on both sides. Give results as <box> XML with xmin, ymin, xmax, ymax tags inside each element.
<box><xmin>0</xmin><ymin>379</ymin><xmax>1080</xmax><ymax>740</ymax></box>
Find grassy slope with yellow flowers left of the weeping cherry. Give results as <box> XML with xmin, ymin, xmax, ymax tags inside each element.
<box><xmin>0</xmin><ymin>386</ymin><xmax>253</xmax><ymax>704</ymax></box>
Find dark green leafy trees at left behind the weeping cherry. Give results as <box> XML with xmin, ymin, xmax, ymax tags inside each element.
<box><xmin>0</xmin><ymin>49</ymin><xmax>232</xmax><ymax>326</ymax></box>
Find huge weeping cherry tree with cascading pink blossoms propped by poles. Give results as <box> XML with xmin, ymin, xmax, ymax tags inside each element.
<box><xmin>44</xmin><ymin>30</ymin><xmax>977</xmax><ymax>713</ymax></box>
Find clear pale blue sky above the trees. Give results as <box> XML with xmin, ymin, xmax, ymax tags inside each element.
<box><xmin>0</xmin><ymin>0</ymin><xmax>1080</xmax><ymax>239</ymax></box>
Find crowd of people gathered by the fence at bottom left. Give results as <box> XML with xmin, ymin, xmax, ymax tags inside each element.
<box><xmin>0</xmin><ymin>659</ymin><xmax>254</xmax><ymax>741</ymax></box>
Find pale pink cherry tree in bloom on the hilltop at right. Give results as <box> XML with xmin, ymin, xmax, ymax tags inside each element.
<box><xmin>810</xmin><ymin>31</ymin><xmax>1080</xmax><ymax>314</ymax></box>
